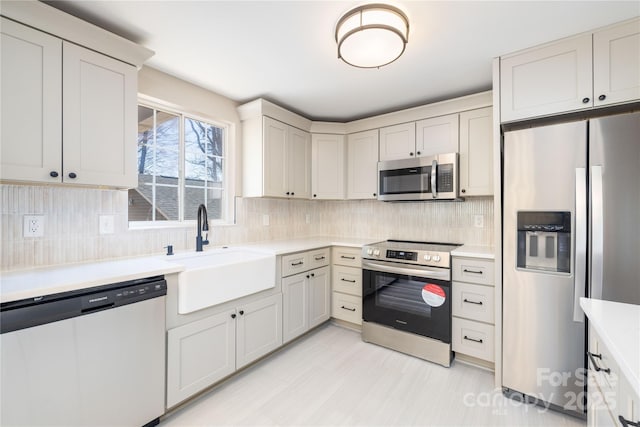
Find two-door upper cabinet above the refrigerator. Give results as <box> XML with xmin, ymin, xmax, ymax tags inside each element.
<box><xmin>500</xmin><ymin>18</ymin><xmax>640</xmax><ymax>122</ymax></box>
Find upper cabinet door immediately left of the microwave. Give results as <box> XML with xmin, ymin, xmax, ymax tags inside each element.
<box><xmin>347</xmin><ymin>129</ymin><xmax>378</xmax><ymax>199</ymax></box>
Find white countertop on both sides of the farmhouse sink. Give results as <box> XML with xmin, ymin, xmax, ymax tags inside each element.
<box><xmin>0</xmin><ymin>237</ymin><xmax>379</xmax><ymax>303</ymax></box>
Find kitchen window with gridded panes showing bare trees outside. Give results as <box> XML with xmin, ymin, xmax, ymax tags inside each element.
<box><xmin>128</xmin><ymin>104</ymin><xmax>233</xmax><ymax>226</ymax></box>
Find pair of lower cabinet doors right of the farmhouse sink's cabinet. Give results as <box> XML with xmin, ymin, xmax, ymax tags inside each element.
<box><xmin>282</xmin><ymin>266</ymin><xmax>331</xmax><ymax>342</ymax></box>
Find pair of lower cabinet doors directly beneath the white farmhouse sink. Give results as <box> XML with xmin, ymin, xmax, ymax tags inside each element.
<box><xmin>167</xmin><ymin>294</ymin><xmax>282</xmax><ymax>408</ymax></box>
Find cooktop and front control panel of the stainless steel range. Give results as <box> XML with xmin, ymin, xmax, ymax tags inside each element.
<box><xmin>362</xmin><ymin>240</ymin><xmax>460</xmax><ymax>268</ymax></box>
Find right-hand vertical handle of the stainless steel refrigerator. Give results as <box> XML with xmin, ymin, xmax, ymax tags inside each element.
<box><xmin>589</xmin><ymin>166</ymin><xmax>604</xmax><ymax>299</ymax></box>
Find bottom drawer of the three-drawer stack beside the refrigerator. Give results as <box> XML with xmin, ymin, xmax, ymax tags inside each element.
<box><xmin>451</xmin><ymin>317</ymin><xmax>495</xmax><ymax>362</ymax></box>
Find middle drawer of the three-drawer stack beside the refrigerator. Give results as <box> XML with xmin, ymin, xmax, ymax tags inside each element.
<box><xmin>452</xmin><ymin>282</ymin><xmax>494</xmax><ymax>323</ymax></box>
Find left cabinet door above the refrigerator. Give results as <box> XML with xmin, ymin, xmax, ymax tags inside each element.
<box><xmin>500</xmin><ymin>34</ymin><xmax>593</xmax><ymax>122</ymax></box>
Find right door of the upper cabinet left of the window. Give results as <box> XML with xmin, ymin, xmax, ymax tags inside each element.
<box><xmin>62</xmin><ymin>42</ymin><xmax>138</xmax><ymax>188</ymax></box>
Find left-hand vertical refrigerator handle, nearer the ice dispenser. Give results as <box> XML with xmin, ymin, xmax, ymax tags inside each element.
<box><xmin>573</xmin><ymin>168</ymin><xmax>587</xmax><ymax>322</ymax></box>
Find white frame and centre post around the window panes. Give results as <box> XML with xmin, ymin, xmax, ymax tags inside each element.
<box><xmin>127</xmin><ymin>95</ymin><xmax>236</xmax><ymax>229</ymax></box>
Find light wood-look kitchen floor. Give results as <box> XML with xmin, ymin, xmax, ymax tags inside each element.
<box><xmin>160</xmin><ymin>324</ymin><xmax>585</xmax><ymax>427</ymax></box>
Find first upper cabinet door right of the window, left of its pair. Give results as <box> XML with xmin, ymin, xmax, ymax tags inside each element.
<box><xmin>262</xmin><ymin>117</ymin><xmax>289</xmax><ymax>197</ymax></box>
